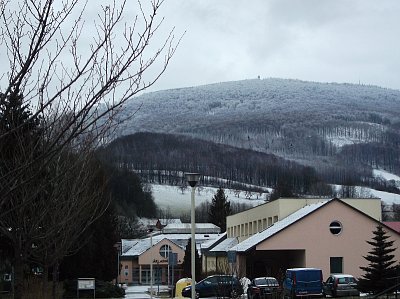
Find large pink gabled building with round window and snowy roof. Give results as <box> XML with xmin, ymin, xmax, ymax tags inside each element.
<box><xmin>230</xmin><ymin>198</ymin><xmax>400</xmax><ymax>277</ymax></box>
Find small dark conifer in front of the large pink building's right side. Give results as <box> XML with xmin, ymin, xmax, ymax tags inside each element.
<box><xmin>359</xmin><ymin>225</ymin><xmax>396</xmax><ymax>294</ymax></box>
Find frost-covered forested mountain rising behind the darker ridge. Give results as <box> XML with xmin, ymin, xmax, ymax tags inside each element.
<box><xmin>118</xmin><ymin>79</ymin><xmax>400</xmax><ymax>180</ymax></box>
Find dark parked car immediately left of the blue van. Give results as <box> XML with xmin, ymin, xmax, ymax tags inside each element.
<box><xmin>247</xmin><ymin>277</ymin><xmax>281</xmax><ymax>299</ymax></box>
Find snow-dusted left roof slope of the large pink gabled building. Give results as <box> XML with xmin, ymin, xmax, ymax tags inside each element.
<box><xmin>231</xmin><ymin>200</ymin><xmax>330</xmax><ymax>252</ymax></box>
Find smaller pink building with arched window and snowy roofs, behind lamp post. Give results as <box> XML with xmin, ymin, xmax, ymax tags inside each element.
<box><xmin>118</xmin><ymin>223</ymin><xmax>225</xmax><ymax>286</ymax></box>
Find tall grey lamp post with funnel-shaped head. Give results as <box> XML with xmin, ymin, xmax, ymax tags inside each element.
<box><xmin>185</xmin><ymin>173</ymin><xmax>201</xmax><ymax>299</ymax></box>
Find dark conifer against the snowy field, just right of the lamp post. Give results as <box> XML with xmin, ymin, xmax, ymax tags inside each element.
<box><xmin>208</xmin><ymin>187</ymin><xmax>231</xmax><ymax>232</ymax></box>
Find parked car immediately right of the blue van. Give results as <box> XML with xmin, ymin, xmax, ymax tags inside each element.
<box><xmin>324</xmin><ymin>274</ymin><xmax>360</xmax><ymax>297</ymax></box>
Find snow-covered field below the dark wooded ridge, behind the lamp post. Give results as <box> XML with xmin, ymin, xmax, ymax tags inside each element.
<box><xmin>151</xmin><ymin>184</ymin><xmax>266</xmax><ymax>213</ymax></box>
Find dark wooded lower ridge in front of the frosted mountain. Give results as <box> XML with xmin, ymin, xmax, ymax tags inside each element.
<box><xmin>100</xmin><ymin>133</ymin><xmax>390</xmax><ymax>196</ymax></box>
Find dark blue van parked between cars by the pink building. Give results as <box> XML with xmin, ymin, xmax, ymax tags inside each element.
<box><xmin>282</xmin><ymin>268</ymin><xmax>323</xmax><ymax>298</ymax></box>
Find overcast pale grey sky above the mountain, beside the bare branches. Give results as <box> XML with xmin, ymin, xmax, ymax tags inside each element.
<box><xmin>143</xmin><ymin>0</ymin><xmax>400</xmax><ymax>90</ymax></box>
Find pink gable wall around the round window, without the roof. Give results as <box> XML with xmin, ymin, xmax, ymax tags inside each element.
<box><xmin>256</xmin><ymin>201</ymin><xmax>400</xmax><ymax>278</ymax></box>
